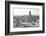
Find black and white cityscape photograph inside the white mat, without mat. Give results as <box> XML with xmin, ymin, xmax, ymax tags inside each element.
<box><xmin>13</xmin><ymin>7</ymin><xmax>39</xmax><ymax>28</ymax></box>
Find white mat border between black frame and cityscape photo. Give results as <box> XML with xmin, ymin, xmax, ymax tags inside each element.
<box><xmin>10</xmin><ymin>4</ymin><xmax>42</xmax><ymax>32</ymax></box>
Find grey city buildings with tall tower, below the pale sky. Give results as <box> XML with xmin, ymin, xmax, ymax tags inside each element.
<box><xmin>13</xmin><ymin>11</ymin><xmax>39</xmax><ymax>28</ymax></box>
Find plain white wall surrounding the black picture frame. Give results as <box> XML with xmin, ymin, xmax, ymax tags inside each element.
<box><xmin>0</xmin><ymin>0</ymin><xmax>46</xmax><ymax>36</ymax></box>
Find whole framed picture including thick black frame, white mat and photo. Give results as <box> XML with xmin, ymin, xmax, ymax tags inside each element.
<box><xmin>5</xmin><ymin>1</ymin><xmax>44</xmax><ymax>35</ymax></box>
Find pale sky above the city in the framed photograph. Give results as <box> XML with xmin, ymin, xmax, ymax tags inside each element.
<box><xmin>13</xmin><ymin>8</ymin><xmax>39</xmax><ymax>16</ymax></box>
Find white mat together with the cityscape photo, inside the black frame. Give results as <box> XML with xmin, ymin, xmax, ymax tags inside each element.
<box><xmin>10</xmin><ymin>4</ymin><xmax>42</xmax><ymax>32</ymax></box>
